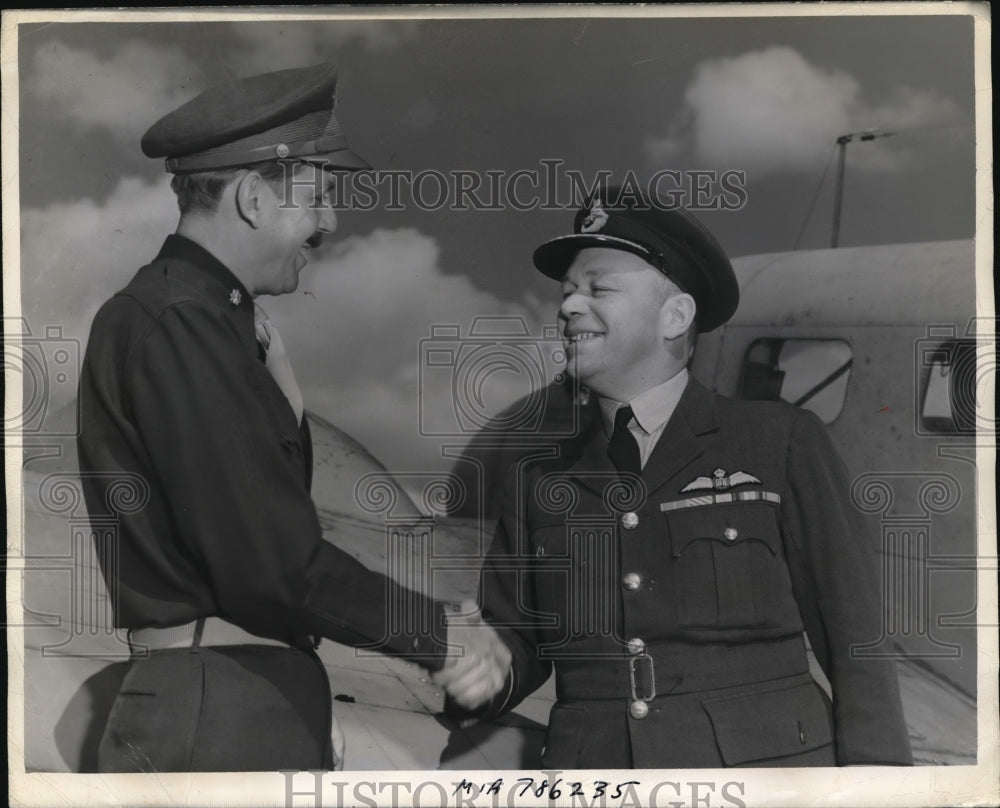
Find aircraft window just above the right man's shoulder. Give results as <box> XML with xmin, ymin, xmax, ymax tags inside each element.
<box><xmin>740</xmin><ymin>339</ymin><xmax>853</xmax><ymax>424</ymax></box>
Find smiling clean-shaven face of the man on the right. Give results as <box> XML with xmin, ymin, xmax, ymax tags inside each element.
<box><xmin>559</xmin><ymin>247</ymin><xmax>694</xmax><ymax>401</ymax></box>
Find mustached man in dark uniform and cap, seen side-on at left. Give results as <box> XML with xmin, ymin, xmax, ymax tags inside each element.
<box><xmin>79</xmin><ymin>65</ymin><xmax>506</xmax><ymax>772</ymax></box>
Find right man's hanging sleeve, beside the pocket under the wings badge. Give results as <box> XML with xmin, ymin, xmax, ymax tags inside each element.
<box><xmin>782</xmin><ymin>411</ymin><xmax>913</xmax><ymax>766</ymax></box>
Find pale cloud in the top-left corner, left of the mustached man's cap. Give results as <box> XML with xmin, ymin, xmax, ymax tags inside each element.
<box><xmin>25</xmin><ymin>40</ymin><xmax>197</xmax><ymax>146</ymax></box>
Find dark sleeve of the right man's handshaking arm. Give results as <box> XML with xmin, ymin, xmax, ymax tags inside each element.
<box><xmin>445</xmin><ymin>463</ymin><xmax>552</xmax><ymax>724</ymax></box>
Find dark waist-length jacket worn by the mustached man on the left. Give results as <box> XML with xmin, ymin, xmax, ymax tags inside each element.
<box><xmin>78</xmin><ymin>235</ymin><xmax>443</xmax><ymax>668</ymax></box>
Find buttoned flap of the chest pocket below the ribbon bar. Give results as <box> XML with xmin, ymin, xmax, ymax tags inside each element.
<box><xmin>664</xmin><ymin>502</ymin><xmax>780</xmax><ymax>556</ymax></box>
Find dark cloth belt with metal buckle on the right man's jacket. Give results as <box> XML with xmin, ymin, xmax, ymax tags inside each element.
<box><xmin>556</xmin><ymin>636</ymin><xmax>809</xmax><ymax>701</ymax></box>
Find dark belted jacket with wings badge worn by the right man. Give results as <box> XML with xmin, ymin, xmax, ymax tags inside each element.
<box><xmin>448</xmin><ymin>379</ymin><xmax>912</xmax><ymax>768</ymax></box>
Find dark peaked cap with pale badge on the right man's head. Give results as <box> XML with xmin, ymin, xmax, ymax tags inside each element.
<box><xmin>534</xmin><ymin>187</ymin><xmax>740</xmax><ymax>332</ymax></box>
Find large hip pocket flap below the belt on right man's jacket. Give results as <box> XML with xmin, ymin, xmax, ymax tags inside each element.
<box><xmin>702</xmin><ymin>682</ymin><xmax>833</xmax><ymax>766</ymax></box>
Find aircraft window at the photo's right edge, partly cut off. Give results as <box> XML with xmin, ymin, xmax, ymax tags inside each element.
<box><xmin>920</xmin><ymin>340</ymin><xmax>976</xmax><ymax>434</ymax></box>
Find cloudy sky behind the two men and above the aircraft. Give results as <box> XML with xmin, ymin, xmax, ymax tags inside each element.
<box><xmin>9</xmin><ymin>13</ymin><xmax>975</xmax><ymax>469</ymax></box>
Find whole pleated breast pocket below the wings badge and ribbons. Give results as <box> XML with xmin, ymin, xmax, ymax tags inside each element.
<box><xmin>664</xmin><ymin>502</ymin><xmax>791</xmax><ymax>628</ymax></box>
